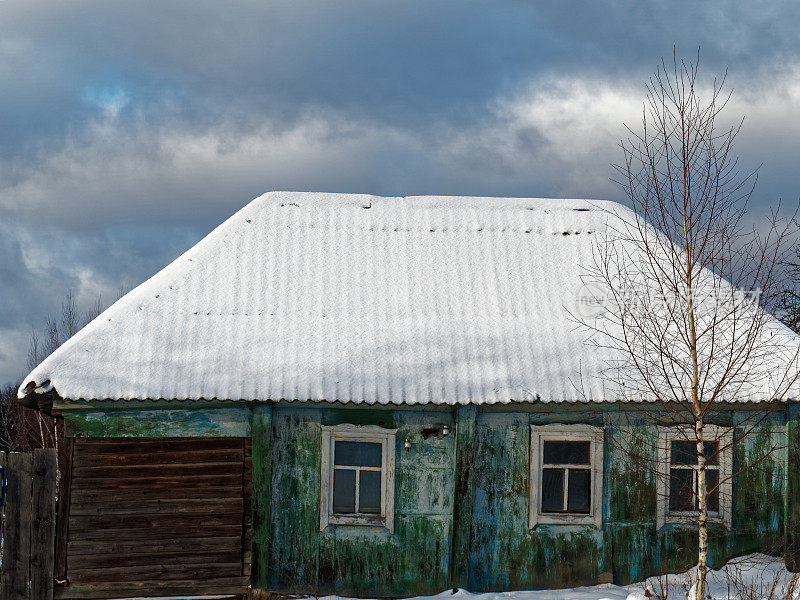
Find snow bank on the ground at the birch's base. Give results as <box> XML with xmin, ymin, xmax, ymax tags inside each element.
<box><xmin>302</xmin><ymin>554</ymin><xmax>800</xmax><ymax>600</ymax></box>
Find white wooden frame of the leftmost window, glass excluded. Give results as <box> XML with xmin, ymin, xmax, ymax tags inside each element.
<box><xmin>319</xmin><ymin>424</ymin><xmax>397</xmax><ymax>533</ymax></box>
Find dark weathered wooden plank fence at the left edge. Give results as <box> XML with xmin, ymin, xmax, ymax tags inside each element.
<box><xmin>0</xmin><ymin>448</ymin><xmax>57</xmax><ymax>600</ymax></box>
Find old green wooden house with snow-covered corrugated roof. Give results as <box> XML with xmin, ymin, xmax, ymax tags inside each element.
<box><xmin>20</xmin><ymin>193</ymin><xmax>800</xmax><ymax>598</ymax></box>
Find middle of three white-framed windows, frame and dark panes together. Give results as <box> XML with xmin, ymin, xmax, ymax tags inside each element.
<box><xmin>529</xmin><ymin>425</ymin><xmax>603</xmax><ymax>528</ymax></box>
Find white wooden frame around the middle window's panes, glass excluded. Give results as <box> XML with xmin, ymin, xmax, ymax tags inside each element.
<box><xmin>528</xmin><ymin>424</ymin><xmax>603</xmax><ymax>529</ymax></box>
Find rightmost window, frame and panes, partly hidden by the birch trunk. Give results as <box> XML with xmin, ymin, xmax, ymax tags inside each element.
<box><xmin>657</xmin><ymin>425</ymin><xmax>733</xmax><ymax>527</ymax></box>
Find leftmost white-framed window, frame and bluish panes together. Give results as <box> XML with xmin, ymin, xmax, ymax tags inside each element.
<box><xmin>320</xmin><ymin>425</ymin><xmax>397</xmax><ymax>531</ymax></box>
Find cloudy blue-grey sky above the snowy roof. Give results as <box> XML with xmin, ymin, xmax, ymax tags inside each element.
<box><xmin>0</xmin><ymin>0</ymin><xmax>800</xmax><ymax>384</ymax></box>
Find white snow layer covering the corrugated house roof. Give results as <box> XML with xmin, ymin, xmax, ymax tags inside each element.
<box><xmin>20</xmin><ymin>192</ymin><xmax>800</xmax><ymax>404</ymax></box>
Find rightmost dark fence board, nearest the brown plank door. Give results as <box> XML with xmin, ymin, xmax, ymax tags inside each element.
<box><xmin>31</xmin><ymin>448</ymin><xmax>56</xmax><ymax>600</ymax></box>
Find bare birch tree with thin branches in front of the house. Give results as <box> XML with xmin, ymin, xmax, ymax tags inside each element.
<box><xmin>581</xmin><ymin>54</ymin><xmax>800</xmax><ymax>600</ymax></box>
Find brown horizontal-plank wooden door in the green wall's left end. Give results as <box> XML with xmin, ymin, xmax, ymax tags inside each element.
<box><xmin>58</xmin><ymin>438</ymin><xmax>249</xmax><ymax>598</ymax></box>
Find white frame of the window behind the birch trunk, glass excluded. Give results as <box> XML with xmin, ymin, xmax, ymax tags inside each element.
<box><xmin>656</xmin><ymin>425</ymin><xmax>733</xmax><ymax>529</ymax></box>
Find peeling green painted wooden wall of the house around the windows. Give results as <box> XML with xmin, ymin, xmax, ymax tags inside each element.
<box><xmin>57</xmin><ymin>405</ymin><xmax>800</xmax><ymax>597</ymax></box>
